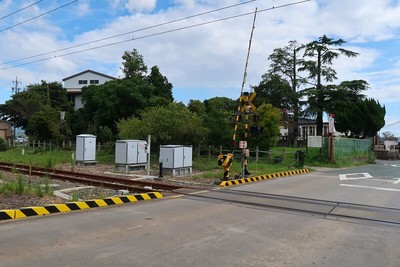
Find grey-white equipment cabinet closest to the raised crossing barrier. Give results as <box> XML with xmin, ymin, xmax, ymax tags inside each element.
<box><xmin>160</xmin><ymin>145</ymin><xmax>193</xmax><ymax>169</ymax></box>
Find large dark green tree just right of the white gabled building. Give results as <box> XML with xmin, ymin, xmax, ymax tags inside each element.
<box><xmin>74</xmin><ymin>49</ymin><xmax>173</xmax><ymax>139</ymax></box>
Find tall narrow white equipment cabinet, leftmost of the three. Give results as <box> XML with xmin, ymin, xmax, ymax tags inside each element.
<box><xmin>76</xmin><ymin>134</ymin><xmax>96</xmax><ymax>163</ymax></box>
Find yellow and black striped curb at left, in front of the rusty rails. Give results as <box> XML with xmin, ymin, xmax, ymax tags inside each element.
<box><xmin>0</xmin><ymin>192</ymin><xmax>163</xmax><ymax>221</ymax></box>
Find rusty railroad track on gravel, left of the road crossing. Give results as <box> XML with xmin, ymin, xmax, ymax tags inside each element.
<box><xmin>0</xmin><ymin>162</ymin><xmax>189</xmax><ymax>193</ymax></box>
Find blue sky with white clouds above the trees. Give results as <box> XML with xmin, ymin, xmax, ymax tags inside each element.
<box><xmin>0</xmin><ymin>0</ymin><xmax>400</xmax><ymax>137</ymax></box>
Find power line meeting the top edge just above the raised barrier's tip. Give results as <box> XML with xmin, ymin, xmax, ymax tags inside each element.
<box><xmin>0</xmin><ymin>0</ymin><xmax>256</xmax><ymax>65</ymax></box>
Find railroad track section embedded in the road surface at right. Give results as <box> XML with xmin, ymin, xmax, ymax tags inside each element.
<box><xmin>184</xmin><ymin>189</ymin><xmax>400</xmax><ymax>227</ymax></box>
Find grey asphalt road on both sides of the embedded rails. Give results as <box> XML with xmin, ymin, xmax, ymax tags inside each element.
<box><xmin>0</xmin><ymin>161</ymin><xmax>400</xmax><ymax>266</ymax></box>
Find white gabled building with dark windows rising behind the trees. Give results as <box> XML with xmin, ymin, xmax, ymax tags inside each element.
<box><xmin>63</xmin><ymin>70</ymin><xmax>117</xmax><ymax>110</ymax></box>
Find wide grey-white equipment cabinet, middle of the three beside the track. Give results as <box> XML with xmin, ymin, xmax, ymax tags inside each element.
<box><xmin>115</xmin><ymin>140</ymin><xmax>147</xmax><ymax>165</ymax></box>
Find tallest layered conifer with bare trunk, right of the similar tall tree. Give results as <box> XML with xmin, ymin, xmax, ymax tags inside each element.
<box><xmin>299</xmin><ymin>35</ymin><xmax>358</xmax><ymax>135</ymax></box>
